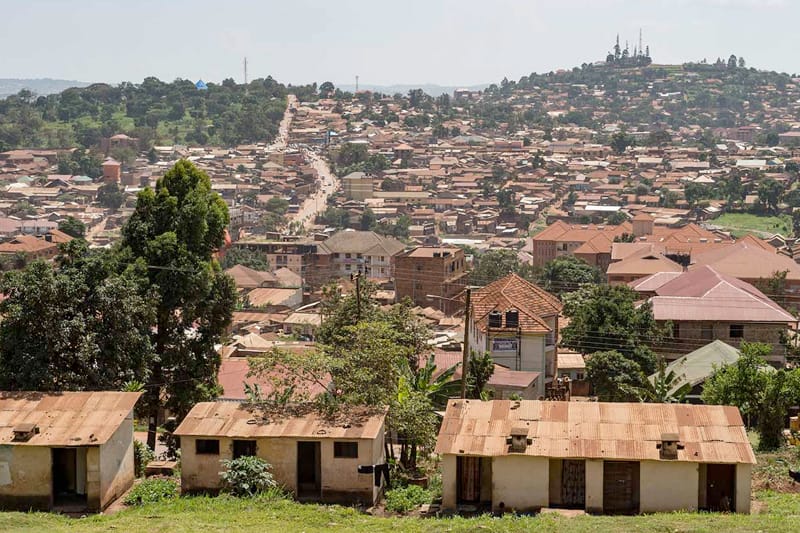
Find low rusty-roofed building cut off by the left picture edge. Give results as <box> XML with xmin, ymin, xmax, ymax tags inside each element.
<box><xmin>0</xmin><ymin>392</ymin><xmax>141</xmax><ymax>512</ymax></box>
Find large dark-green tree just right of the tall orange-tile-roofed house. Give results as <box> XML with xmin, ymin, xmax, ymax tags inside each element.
<box><xmin>561</xmin><ymin>285</ymin><xmax>664</xmax><ymax>374</ymax></box>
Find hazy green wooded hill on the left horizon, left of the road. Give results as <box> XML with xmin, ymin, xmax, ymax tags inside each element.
<box><xmin>0</xmin><ymin>77</ymin><xmax>316</xmax><ymax>151</ymax></box>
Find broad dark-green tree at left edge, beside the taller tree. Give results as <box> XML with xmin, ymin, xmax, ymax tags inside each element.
<box><xmin>0</xmin><ymin>245</ymin><xmax>154</xmax><ymax>391</ymax></box>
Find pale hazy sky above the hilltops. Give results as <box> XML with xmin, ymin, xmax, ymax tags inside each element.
<box><xmin>0</xmin><ymin>0</ymin><xmax>800</xmax><ymax>85</ymax></box>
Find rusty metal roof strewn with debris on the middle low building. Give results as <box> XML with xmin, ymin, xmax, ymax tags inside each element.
<box><xmin>175</xmin><ymin>402</ymin><xmax>386</xmax><ymax>439</ymax></box>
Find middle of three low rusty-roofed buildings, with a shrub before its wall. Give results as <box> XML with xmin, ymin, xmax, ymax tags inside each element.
<box><xmin>175</xmin><ymin>401</ymin><xmax>386</xmax><ymax>506</ymax></box>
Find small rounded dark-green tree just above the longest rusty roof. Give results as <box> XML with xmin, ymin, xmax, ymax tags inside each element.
<box><xmin>586</xmin><ymin>350</ymin><xmax>647</xmax><ymax>402</ymax></box>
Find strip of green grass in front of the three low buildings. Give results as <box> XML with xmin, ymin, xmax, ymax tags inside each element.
<box><xmin>0</xmin><ymin>487</ymin><xmax>800</xmax><ymax>533</ymax></box>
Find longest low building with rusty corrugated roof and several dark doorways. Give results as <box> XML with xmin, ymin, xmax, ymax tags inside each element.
<box><xmin>436</xmin><ymin>400</ymin><xmax>756</xmax><ymax>514</ymax></box>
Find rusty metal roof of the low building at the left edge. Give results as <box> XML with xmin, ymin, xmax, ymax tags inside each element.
<box><xmin>0</xmin><ymin>392</ymin><xmax>141</xmax><ymax>446</ymax></box>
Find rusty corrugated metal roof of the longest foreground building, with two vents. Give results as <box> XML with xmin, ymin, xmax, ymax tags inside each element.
<box><xmin>436</xmin><ymin>400</ymin><xmax>756</xmax><ymax>464</ymax></box>
